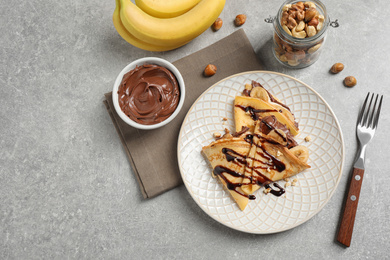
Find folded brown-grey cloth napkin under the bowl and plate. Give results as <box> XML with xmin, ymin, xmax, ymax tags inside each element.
<box><xmin>103</xmin><ymin>29</ymin><xmax>263</xmax><ymax>198</ymax></box>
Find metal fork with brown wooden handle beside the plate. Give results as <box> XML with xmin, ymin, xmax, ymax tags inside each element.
<box><xmin>337</xmin><ymin>93</ymin><xmax>383</xmax><ymax>247</ymax></box>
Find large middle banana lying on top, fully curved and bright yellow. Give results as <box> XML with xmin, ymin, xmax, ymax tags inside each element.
<box><xmin>120</xmin><ymin>0</ymin><xmax>226</xmax><ymax>46</ymax></box>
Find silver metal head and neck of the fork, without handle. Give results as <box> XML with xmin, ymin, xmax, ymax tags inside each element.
<box><xmin>354</xmin><ymin>93</ymin><xmax>383</xmax><ymax>169</ymax></box>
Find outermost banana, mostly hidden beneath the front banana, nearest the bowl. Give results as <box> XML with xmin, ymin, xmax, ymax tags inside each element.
<box><xmin>112</xmin><ymin>0</ymin><xmax>186</xmax><ymax>51</ymax></box>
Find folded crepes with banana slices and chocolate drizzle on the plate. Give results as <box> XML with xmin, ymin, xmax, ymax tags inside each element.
<box><xmin>202</xmin><ymin>81</ymin><xmax>310</xmax><ymax>210</ymax></box>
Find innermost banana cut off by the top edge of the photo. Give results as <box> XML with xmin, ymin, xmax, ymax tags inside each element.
<box><xmin>135</xmin><ymin>0</ymin><xmax>200</xmax><ymax>18</ymax></box>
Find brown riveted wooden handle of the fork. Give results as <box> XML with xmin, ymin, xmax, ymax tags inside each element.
<box><xmin>337</xmin><ymin>168</ymin><xmax>364</xmax><ymax>247</ymax></box>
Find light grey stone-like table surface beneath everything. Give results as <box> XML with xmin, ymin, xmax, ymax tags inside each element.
<box><xmin>0</xmin><ymin>0</ymin><xmax>390</xmax><ymax>259</ymax></box>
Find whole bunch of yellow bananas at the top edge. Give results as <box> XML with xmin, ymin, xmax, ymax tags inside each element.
<box><xmin>112</xmin><ymin>0</ymin><xmax>226</xmax><ymax>51</ymax></box>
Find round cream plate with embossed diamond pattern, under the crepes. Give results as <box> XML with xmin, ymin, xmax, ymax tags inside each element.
<box><xmin>178</xmin><ymin>71</ymin><xmax>344</xmax><ymax>234</ymax></box>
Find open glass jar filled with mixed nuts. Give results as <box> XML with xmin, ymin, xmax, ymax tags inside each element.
<box><xmin>273</xmin><ymin>0</ymin><xmax>329</xmax><ymax>68</ymax></box>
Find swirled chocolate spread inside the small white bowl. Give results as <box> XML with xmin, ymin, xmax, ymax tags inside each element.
<box><xmin>118</xmin><ymin>64</ymin><xmax>180</xmax><ymax>125</ymax></box>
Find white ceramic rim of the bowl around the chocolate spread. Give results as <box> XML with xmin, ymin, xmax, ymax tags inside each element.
<box><xmin>112</xmin><ymin>57</ymin><xmax>185</xmax><ymax>130</ymax></box>
